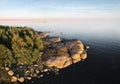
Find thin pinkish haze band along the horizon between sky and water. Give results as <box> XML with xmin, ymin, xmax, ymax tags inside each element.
<box><xmin>0</xmin><ymin>17</ymin><xmax>120</xmax><ymax>22</ymax></box>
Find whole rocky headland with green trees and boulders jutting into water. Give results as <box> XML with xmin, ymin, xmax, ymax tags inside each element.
<box><xmin>0</xmin><ymin>26</ymin><xmax>89</xmax><ymax>84</ymax></box>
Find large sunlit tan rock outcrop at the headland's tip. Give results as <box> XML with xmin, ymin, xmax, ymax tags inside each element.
<box><xmin>42</xmin><ymin>34</ymin><xmax>87</xmax><ymax>69</ymax></box>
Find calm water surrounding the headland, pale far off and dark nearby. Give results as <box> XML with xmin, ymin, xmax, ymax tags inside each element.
<box><xmin>0</xmin><ymin>19</ymin><xmax>120</xmax><ymax>84</ymax></box>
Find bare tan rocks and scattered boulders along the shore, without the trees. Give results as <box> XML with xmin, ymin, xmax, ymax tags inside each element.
<box><xmin>5</xmin><ymin>32</ymin><xmax>89</xmax><ymax>83</ymax></box>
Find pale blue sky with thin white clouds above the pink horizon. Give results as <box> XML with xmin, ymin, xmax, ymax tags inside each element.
<box><xmin>0</xmin><ymin>0</ymin><xmax>120</xmax><ymax>19</ymax></box>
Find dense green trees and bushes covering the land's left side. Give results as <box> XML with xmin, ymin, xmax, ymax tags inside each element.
<box><xmin>0</xmin><ymin>26</ymin><xmax>44</xmax><ymax>81</ymax></box>
